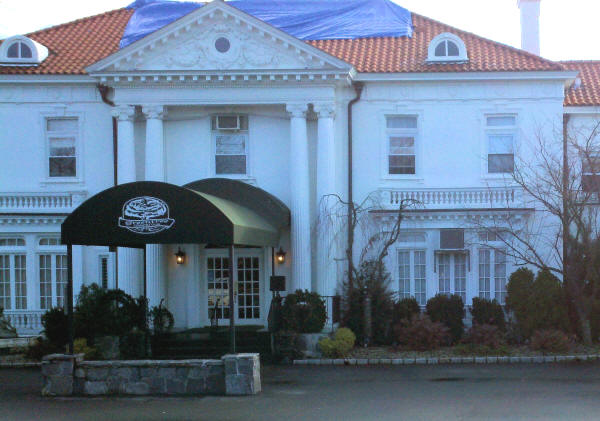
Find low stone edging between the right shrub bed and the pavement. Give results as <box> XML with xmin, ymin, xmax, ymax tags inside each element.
<box><xmin>293</xmin><ymin>354</ymin><xmax>600</xmax><ymax>366</ymax></box>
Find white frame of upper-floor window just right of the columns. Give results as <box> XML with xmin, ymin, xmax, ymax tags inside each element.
<box><xmin>381</xmin><ymin>110</ymin><xmax>423</xmax><ymax>181</ymax></box>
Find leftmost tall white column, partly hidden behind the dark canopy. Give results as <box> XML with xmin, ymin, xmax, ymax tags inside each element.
<box><xmin>112</xmin><ymin>105</ymin><xmax>143</xmax><ymax>297</ymax></box>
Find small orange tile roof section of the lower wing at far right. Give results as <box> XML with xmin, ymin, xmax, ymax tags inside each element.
<box><xmin>560</xmin><ymin>60</ymin><xmax>600</xmax><ymax>106</ymax></box>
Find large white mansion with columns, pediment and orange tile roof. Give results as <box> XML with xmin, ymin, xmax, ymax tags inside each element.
<box><xmin>0</xmin><ymin>0</ymin><xmax>600</xmax><ymax>333</ymax></box>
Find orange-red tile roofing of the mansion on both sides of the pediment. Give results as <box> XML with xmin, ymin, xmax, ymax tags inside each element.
<box><xmin>0</xmin><ymin>9</ymin><xmax>600</xmax><ymax>106</ymax></box>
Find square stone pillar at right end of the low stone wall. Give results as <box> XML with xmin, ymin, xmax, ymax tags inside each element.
<box><xmin>221</xmin><ymin>354</ymin><xmax>262</xmax><ymax>395</ymax></box>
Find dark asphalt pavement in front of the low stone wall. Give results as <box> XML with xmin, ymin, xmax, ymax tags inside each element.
<box><xmin>0</xmin><ymin>361</ymin><xmax>600</xmax><ymax>421</ymax></box>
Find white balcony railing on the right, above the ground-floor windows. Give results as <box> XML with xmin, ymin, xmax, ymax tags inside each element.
<box><xmin>381</xmin><ymin>187</ymin><xmax>523</xmax><ymax>209</ymax></box>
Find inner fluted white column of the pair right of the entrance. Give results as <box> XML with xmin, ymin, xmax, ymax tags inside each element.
<box><xmin>287</xmin><ymin>104</ymin><xmax>311</xmax><ymax>290</ymax></box>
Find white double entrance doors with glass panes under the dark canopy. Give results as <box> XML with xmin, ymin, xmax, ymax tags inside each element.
<box><xmin>206</xmin><ymin>255</ymin><xmax>262</xmax><ymax>325</ymax></box>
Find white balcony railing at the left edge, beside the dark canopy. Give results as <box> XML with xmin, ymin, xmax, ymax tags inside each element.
<box><xmin>0</xmin><ymin>192</ymin><xmax>85</xmax><ymax>213</ymax></box>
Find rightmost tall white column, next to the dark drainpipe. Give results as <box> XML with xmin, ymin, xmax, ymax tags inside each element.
<box><xmin>314</xmin><ymin>103</ymin><xmax>337</xmax><ymax>295</ymax></box>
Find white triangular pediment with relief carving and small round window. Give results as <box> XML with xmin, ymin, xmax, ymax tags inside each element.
<box><xmin>112</xmin><ymin>17</ymin><xmax>333</xmax><ymax>71</ymax></box>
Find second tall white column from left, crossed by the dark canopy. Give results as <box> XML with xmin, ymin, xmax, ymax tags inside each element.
<box><xmin>142</xmin><ymin>105</ymin><xmax>167</xmax><ymax>306</ymax></box>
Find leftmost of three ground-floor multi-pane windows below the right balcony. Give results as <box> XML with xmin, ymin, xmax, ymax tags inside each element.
<box><xmin>398</xmin><ymin>250</ymin><xmax>427</xmax><ymax>305</ymax></box>
